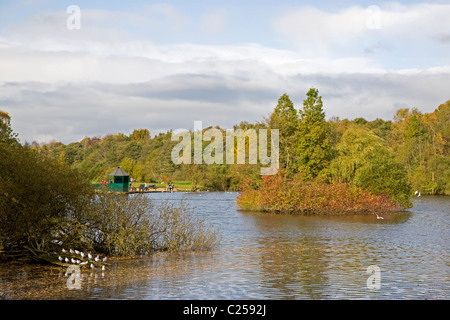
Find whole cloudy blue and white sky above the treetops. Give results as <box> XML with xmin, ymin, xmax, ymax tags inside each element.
<box><xmin>0</xmin><ymin>0</ymin><xmax>450</xmax><ymax>144</ymax></box>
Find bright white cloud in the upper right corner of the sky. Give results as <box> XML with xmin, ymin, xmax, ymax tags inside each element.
<box><xmin>273</xmin><ymin>3</ymin><xmax>450</xmax><ymax>57</ymax></box>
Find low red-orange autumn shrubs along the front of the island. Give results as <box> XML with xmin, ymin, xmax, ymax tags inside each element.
<box><xmin>237</xmin><ymin>171</ymin><xmax>401</xmax><ymax>215</ymax></box>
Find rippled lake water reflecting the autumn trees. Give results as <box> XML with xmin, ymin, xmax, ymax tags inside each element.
<box><xmin>0</xmin><ymin>192</ymin><xmax>450</xmax><ymax>299</ymax></box>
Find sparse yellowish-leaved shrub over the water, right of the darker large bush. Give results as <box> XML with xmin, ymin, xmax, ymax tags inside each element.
<box><xmin>89</xmin><ymin>194</ymin><xmax>218</xmax><ymax>256</ymax></box>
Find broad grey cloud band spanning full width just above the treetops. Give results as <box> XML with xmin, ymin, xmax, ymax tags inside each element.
<box><xmin>0</xmin><ymin>73</ymin><xmax>450</xmax><ymax>143</ymax></box>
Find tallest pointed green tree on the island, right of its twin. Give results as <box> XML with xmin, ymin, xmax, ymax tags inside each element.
<box><xmin>296</xmin><ymin>88</ymin><xmax>331</xmax><ymax>179</ymax></box>
